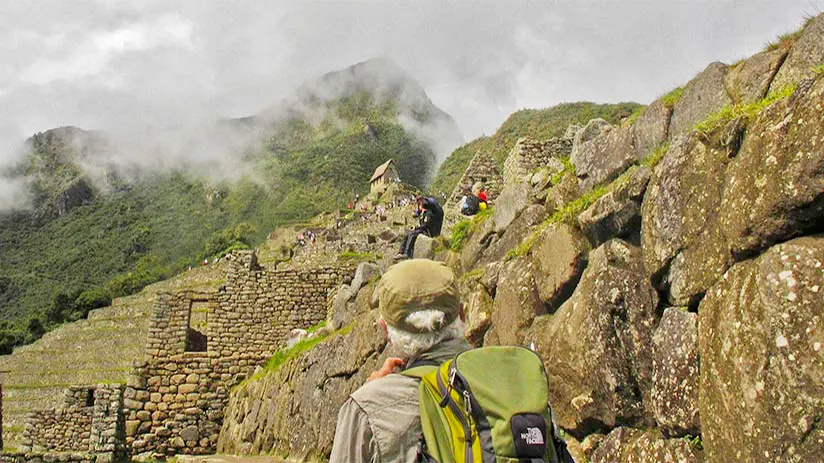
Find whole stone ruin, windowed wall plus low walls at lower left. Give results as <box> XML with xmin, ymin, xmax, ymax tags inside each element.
<box><xmin>7</xmin><ymin>251</ymin><xmax>353</xmax><ymax>463</ymax></box>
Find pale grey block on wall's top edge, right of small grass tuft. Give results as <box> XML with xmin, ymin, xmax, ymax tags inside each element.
<box><xmin>669</xmin><ymin>62</ymin><xmax>732</xmax><ymax>136</ymax></box>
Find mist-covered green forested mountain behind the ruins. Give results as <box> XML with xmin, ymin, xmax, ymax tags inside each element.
<box><xmin>0</xmin><ymin>59</ymin><xmax>462</xmax><ymax>350</ymax></box>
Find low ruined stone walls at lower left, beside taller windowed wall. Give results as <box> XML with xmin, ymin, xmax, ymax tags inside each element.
<box><xmin>16</xmin><ymin>384</ymin><xmax>124</xmax><ymax>461</ymax></box>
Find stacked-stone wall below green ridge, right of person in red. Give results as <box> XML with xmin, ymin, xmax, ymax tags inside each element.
<box><xmin>503</xmin><ymin>137</ymin><xmax>572</xmax><ymax>185</ymax></box>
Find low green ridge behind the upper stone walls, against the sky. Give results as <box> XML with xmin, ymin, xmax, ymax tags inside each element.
<box><xmin>430</xmin><ymin>102</ymin><xmax>642</xmax><ymax>194</ymax></box>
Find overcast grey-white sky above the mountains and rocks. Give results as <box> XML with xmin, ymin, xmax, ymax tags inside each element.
<box><xmin>0</xmin><ymin>0</ymin><xmax>824</xmax><ymax>157</ymax></box>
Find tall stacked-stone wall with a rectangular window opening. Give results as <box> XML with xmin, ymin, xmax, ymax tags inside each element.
<box><xmin>125</xmin><ymin>251</ymin><xmax>351</xmax><ymax>455</ymax></box>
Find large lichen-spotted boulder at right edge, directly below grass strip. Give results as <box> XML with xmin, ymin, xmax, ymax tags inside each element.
<box><xmin>719</xmin><ymin>78</ymin><xmax>824</xmax><ymax>257</ymax></box>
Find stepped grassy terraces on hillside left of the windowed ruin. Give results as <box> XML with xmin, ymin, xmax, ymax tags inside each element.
<box><xmin>0</xmin><ymin>260</ymin><xmax>225</xmax><ymax>448</ymax></box>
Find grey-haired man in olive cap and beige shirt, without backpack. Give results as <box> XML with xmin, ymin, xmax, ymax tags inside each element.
<box><xmin>330</xmin><ymin>259</ymin><xmax>470</xmax><ymax>463</ymax></box>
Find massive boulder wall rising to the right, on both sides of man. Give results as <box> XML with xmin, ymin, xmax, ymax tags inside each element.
<box><xmin>212</xmin><ymin>16</ymin><xmax>824</xmax><ymax>463</ymax></box>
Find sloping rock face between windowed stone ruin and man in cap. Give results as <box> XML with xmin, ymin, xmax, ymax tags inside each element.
<box><xmin>217</xmin><ymin>312</ymin><xmax>384</xmax><ymax>459</ymax></box>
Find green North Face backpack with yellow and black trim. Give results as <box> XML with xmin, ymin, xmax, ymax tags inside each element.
<box><xmin>402</xmin><ymin>346</ymin><xmax>573</xmax><ymax>463</ymax></box>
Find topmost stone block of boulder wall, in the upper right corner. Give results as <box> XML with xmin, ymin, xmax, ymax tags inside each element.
<box><xmin>770</xmin><ymin>14</ymin><xmax>824</xmax><ymax>91</ymax></box>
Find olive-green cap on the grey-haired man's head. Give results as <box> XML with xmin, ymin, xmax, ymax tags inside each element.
<box><xmin>378</xmin><ymin>259</ymin><xmax>461</xmax><ymax>333</ymax></box>
